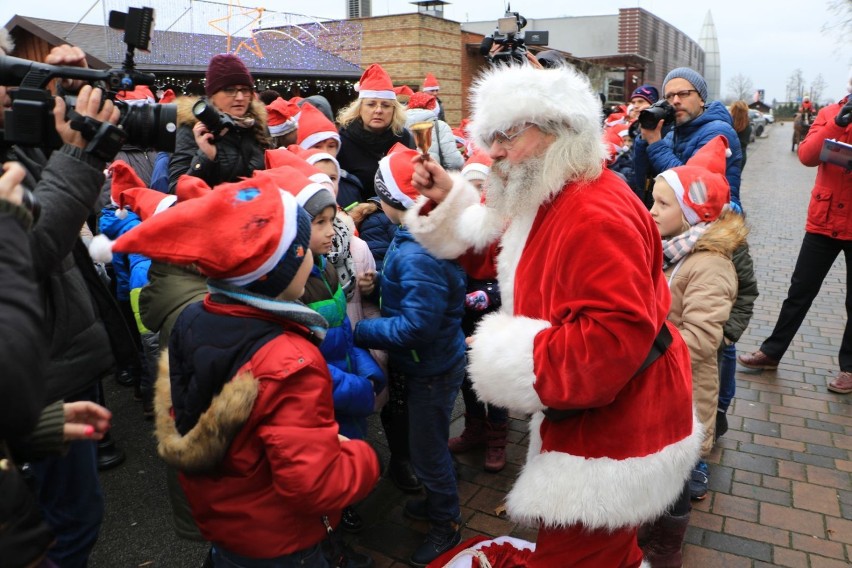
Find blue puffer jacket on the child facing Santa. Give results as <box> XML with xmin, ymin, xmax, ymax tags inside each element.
<box><xmin>355</xmin><ymin>226</ymin><xmax>466</xmax><ymax>377</ymax></box>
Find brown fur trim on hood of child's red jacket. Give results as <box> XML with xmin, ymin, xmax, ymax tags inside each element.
<box><xmin>154</xmin><ymin>350</ymin><xmax>258</xmax><ymax>474</ymax></box>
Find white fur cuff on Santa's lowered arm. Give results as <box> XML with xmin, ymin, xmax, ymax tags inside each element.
<box><xmin>468</xmin><ymin>313</ymin><xmax>550</xmax><ymax>414</ymax></box>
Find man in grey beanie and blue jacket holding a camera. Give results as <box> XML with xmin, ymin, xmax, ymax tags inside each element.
<box><xmin>634</xmin><ymin>67</ymin><xmax>743</xmax><ymax>212</ymax></box>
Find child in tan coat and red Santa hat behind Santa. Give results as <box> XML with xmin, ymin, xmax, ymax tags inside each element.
<box><xmin>640</xmin><ymin>136</ymin><xmax>748</xmax><ymax>566</ymax></box>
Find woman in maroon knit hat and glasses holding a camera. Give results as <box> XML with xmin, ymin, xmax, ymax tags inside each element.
<box><xmin>169</xmin><ymin>54</ymin><xmax>271</xmax><ymax>193</ymax></box>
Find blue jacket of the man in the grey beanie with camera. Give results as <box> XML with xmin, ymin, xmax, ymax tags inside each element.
<box><xmin>634</xmin><ymin>101</ymin><xmax>743</xmax><ymax>211</ymax></box>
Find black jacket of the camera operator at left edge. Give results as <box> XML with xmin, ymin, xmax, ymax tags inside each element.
<box><xmin>4</xmin><ymin>144</ymin><xmax>137</xmax><ymax>403</ymax></box>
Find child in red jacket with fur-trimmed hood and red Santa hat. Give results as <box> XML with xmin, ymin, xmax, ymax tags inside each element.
<box><xmin>96</xmin><ymin>177</ymin><xmax>379</xmax><ymax>568</ymax></box>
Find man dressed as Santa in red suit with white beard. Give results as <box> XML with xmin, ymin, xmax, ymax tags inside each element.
<box><xmin>406</xmin><ymin>66</ymin><xmax>702</xmax><ymax>568</ymax></box>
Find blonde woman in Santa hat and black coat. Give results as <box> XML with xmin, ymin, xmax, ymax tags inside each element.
<box><xmin>337</xmin><ymin>63</ymin><xmax>414</xmax><ymax>203</ymax></box>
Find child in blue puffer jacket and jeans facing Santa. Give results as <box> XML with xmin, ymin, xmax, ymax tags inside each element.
<box><xmin>355</xmin><ymin>144</ymin><xmax>465</xmax><ymax>566</ymax></box>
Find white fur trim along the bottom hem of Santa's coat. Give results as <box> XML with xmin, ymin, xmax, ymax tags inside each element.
<box><xmin>510</xmin><ymin>412</ymin><xmax>704</xmax><ymax>530</ymax></box>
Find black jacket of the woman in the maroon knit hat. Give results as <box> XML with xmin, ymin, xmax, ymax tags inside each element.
<box><xmin>169</xmin><ymin>97</ymin><xmax>271</xmax><ymax>193</ymax></box>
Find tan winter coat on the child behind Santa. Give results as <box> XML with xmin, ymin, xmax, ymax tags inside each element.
<box><xmin>665</xmin><ymin>212</ymin><xmax>748</xmax><ymax>457</ymax></box>
